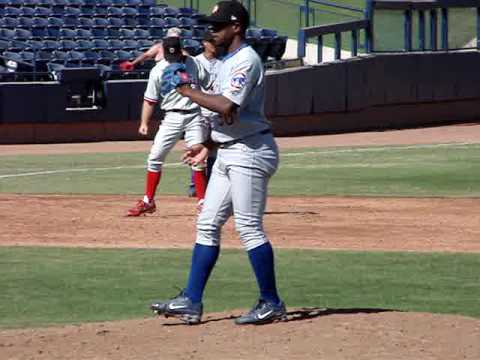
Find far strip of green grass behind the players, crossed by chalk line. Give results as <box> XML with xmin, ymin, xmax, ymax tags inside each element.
<box><xmin>0</xmin><ymin>144</ymin><xmax>480</xmax><ymax>197</ymax></box>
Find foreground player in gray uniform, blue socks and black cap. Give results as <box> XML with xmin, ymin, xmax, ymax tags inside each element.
<box><xmin>151</xmin><ymin>1</ymin><xmax>286</xmax><ymax>324</ymax></box>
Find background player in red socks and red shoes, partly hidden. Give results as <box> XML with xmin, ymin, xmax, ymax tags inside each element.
<box><xmin>127</xmin><ymin>37</ymin><xmax>209</xmax><ymax>216</ymax></box>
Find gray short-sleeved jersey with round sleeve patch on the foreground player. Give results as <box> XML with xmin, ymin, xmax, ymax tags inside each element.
<box><xmin>211</xmin><ymin>45</ymin><xmax>270</xmax><ymax>142</ymax></box>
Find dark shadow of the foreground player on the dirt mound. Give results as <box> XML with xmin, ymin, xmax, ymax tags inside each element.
<box><xmin>164</xmin><ymin>307</ymin><xmax>399</xmax><ymax>326</ymax></box>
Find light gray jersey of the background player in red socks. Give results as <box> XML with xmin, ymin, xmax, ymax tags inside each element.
<box><xmin>144</xmin><ymin>56</ymin><xmax>210</xmax><ymax>111</ymax></box>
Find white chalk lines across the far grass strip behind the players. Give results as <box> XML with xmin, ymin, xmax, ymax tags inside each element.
<box><xmin>0</xmin><ymin>142</ymin><xmax>478</xmax><ymax>180</ymax></box>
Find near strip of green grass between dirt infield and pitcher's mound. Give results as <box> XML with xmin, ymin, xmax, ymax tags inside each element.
<box><xmin>0</xmin><ymin>247</ymin><xmax>480</xmax><ymax>328</ymax></box>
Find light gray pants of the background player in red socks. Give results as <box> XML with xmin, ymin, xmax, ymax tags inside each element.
<box><xmin>147</xmin><ymin>111</ymin><xmax>208</xmax><ymax>172</ymax></box>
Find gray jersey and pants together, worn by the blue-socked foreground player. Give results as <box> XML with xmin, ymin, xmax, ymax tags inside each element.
<box><xmin>196</xmin><ymin>45</ymin><xmax>279</xmax><ymax>250</ymax></box>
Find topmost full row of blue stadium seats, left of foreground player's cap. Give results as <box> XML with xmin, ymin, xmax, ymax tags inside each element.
<box><xmin>0</xmin><ymin>6</ymin><xmax>199</xmax><ymax>18</ymax></box>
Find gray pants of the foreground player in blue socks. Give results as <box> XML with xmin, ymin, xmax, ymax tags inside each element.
<box><xmin>196</xmin><ymin>134</ymin><xmax>278</xmax><ymax>251</ymax></box>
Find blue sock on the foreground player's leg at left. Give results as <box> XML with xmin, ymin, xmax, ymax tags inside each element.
<box><xmin>185</xmin><ymin>244</ymin><xmax>220</xmax><ymax>303</ymax></box>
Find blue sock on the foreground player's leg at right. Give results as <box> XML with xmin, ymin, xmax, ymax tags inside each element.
<box><xmin>248</xmin><ymin>242</ymin><xmax>280</xmax><ymax>305</ymax></box>
